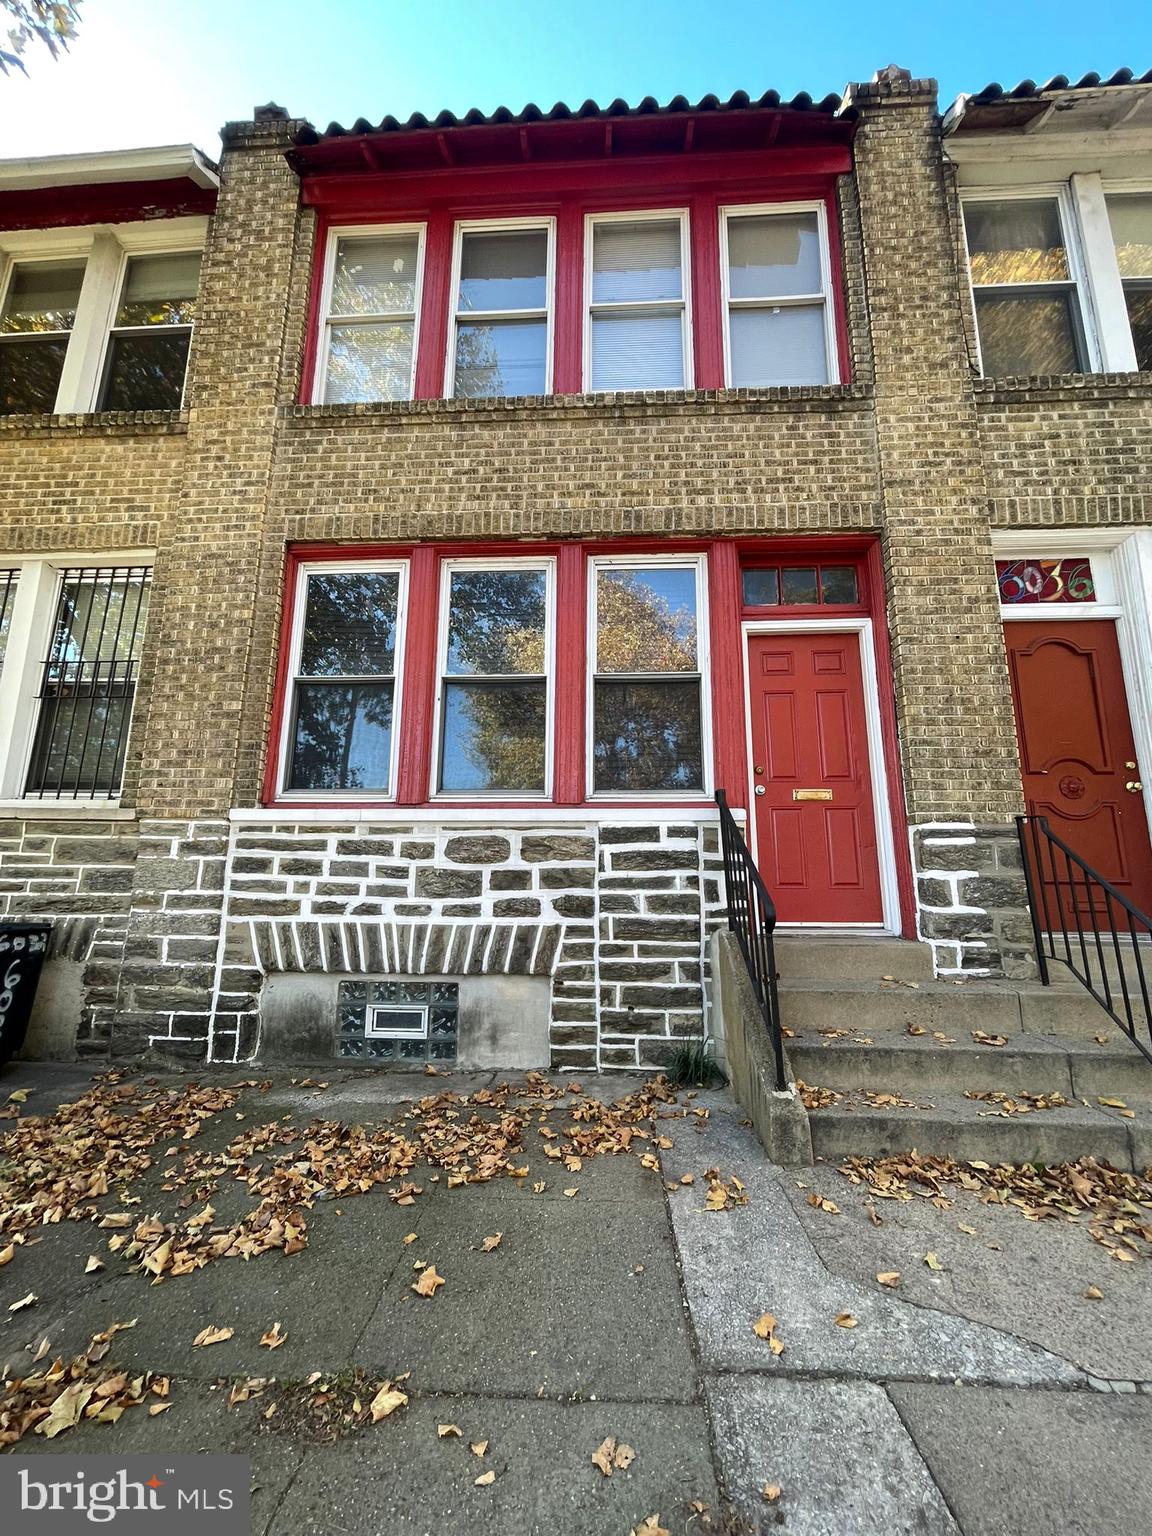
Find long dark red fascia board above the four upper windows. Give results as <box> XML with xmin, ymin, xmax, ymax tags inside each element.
<box><xmin>301</xmin><ymin>144</ymin><xmax>852</xmax><ymax>217</ymax></box>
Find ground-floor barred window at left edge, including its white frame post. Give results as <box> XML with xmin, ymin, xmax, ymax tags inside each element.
<box><xmin>0</xmin><ymin>561</ymin><xmax>152</xmax><ymax>800</ymax></box>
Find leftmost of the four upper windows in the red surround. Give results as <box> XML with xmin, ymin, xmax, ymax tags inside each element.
<box><xmin>318</xmin><ymin>224</ymin><xmax>424</xmax><ymax>404</ymax></box>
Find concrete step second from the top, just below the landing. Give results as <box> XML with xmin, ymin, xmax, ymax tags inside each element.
<box><xmin>780</xmin><ymin>975</ymin><xmax>1117</xmax><ymax>1040</ymax></box>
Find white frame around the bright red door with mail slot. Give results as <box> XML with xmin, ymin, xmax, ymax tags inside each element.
<box><xmin>740</xmin><ymin>616</ymin><xmax>900</xmax><ymax>934</ymax></box>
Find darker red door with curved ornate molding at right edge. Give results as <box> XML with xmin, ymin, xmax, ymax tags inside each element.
<box><xmin>1005</xmin><ymin>619</ymin><xmax>1152</xmax><ymax>919</ymax></box>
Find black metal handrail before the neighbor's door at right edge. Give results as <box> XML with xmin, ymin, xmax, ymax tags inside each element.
<box><xmin>1015</xmin><ymin>816</ymin><xmax>1152</xmax><ymax>1061</ymax></box>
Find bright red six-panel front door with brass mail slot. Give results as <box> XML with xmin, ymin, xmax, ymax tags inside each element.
<box><xmin>748</xmin><ymin>631</ymin><xmax>883</xmax><ymax>923</ymax></box>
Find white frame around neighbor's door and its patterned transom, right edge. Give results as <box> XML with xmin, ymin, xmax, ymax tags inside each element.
<box><xmin>992</xmin><ymin>528</ymin><xmax>1152</xmax><ymax>836</ymax></box>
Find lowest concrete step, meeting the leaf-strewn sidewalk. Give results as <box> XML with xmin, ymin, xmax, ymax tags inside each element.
<box><xmin>809</xmin><ymin>1094</ymin><xmax>1152</xmax><ymax>1172</ymax></box>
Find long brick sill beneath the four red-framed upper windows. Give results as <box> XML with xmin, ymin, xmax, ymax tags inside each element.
<box><xmin>281</xmin><ymin>384</ymin><xmax>874</xmax><ymax>427</ymax></box>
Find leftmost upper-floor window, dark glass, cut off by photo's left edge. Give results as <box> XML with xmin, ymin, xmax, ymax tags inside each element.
<box><xmin>0</xmin><ymin>261</ymin><xmax>84</xmax><ymax>416</ymax></box>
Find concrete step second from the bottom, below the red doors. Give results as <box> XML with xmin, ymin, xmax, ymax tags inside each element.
<box><xmin>786</xmin><ymin>1029</ymin><xmax>1152</xmax><ymax>1101</ymax></box>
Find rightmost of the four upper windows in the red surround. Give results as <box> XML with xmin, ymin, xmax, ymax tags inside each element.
<box><xmin>720</xmin><ymin>203</ymin><xmax>839</xmax><ymax>389</ymax></box>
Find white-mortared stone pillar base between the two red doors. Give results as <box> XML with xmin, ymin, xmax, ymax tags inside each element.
<box><xmin>911</xmin><ymin>822</ymin><xmax>1037</xmax><ymax>980</ymax></box>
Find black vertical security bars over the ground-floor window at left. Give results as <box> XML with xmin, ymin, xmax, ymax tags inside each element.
<box><xmin>25</xmin><ymin>565</ymin><xmax>152</xmax><ymax>800</ymax></box>
